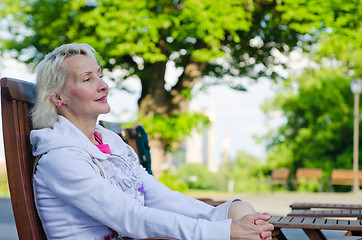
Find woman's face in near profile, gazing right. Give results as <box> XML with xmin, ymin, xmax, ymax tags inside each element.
<box><xmin>59</xmin><ymin>54</ymin><xmax>110</xmax><ymax>122</ymax></box>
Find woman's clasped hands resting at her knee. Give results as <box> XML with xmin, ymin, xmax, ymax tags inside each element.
<box><xmin>230</xmin><ymin>213</ymin><xmax>274</xmax><ymax>240</ymax></box>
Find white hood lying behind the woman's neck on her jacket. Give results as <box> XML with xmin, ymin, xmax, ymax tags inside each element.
<box><xmin>30</xmin><ymin>116</ymin><xmax>108</xmax><ymax>159</ymax></box>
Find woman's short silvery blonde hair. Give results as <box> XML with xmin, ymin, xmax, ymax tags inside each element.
<box><xmin>31</xmin><ymin>43</ymin><xmax>96</xmax><ymax>129</ymax></box>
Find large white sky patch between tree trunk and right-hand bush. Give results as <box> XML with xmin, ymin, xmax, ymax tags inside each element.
<box><xmin>192</xmin><ymin>79</ymin><xmax>282</xmax><ymax>162</ymax></box>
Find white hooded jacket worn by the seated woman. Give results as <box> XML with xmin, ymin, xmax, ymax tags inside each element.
<box><xmin>30</xmin><ymin>116</ymin><xmax>233</xmax><ymax>240</ymax></box>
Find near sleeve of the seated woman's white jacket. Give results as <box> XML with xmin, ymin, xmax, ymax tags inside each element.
<box><xmin>37</xmin><ymin>149</ymin><xmax>231</xmax><ymax>240</ymax></box>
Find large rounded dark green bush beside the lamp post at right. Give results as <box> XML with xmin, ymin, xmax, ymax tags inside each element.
<box><xmin>264</xmin><ymin>69</ymin><xmax>353</xmax><ymax>173</ymax></box>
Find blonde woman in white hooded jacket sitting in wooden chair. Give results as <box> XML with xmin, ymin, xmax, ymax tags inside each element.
<box><xmin>30</xmin><ymin>44</ymin><xmax>273</xmax><ymax>240</ymax></box>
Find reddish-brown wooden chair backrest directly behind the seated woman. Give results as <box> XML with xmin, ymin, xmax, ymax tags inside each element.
<box><xmin>0</xmin><ymin>78</ymin><xmax>46</xmax><ymax>240</ymax></box>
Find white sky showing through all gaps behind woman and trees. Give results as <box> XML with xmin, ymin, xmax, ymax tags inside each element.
<box><xmin>0</xmin><ymin>59</ymin><xmax>282</xmax><ymax>162</ymax></box>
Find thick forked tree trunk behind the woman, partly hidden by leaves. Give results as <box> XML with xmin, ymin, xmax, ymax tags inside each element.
<box><xmin>138</xmin><ymin>58</ymin><xmax>207</xmax><ymax>177</ymax></box>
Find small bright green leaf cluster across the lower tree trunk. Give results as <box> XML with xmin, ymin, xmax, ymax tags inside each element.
<box><xmin>137</xmin><ymin>112</ymin><xmax>210</xmax><ymax>148</ymax></box>
